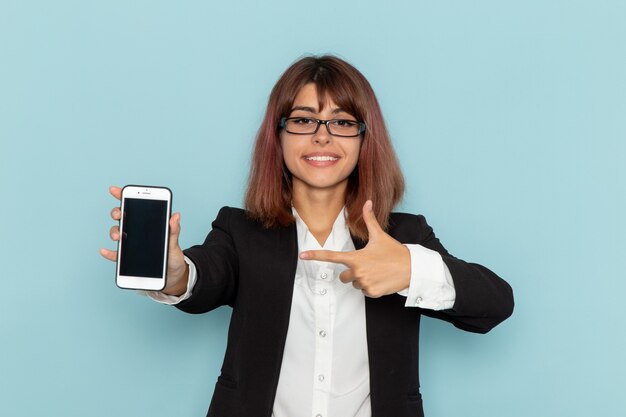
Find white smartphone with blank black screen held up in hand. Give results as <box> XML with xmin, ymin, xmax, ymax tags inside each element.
<box><xmin>115</xmin><ymin>185</ymin><xmax>172</xmax><ymax>291</ymax></box>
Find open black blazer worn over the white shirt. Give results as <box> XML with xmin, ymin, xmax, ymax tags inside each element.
<box><xmin>177</xmin><ymin>207</ymin><xmax>513</xmax><ymax>417</ymax></box>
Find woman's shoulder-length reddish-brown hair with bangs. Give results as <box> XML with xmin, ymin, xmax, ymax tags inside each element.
<box><xmin>245</xmin><ymin>55</ymin><xmax>404</xmax><ymax>241</ymax></box>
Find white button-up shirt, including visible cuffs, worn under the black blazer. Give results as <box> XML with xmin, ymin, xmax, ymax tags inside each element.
<box><xmin>148</xmin><ymin>209</ymin><xmax>455</xmax><ymax>417</ymax></box>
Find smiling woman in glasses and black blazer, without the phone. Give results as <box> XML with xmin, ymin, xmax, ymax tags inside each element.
<box><xmin>102</xmin><ymin>56</ymin><xmax>513</xmax><ymax>417</ymax></box>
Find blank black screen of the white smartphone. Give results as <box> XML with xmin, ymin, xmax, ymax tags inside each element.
<box><xmin>119</xmin><ymin>198</ymin><xmax>169</xmax><ymax>278</ymax></box>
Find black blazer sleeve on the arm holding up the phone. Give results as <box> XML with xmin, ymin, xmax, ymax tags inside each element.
<box><xmin>176</xmin><ymin>207</ymin><xmax>239</xmax><ymax>314</ymax></box>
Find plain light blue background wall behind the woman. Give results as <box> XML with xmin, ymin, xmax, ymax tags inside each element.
<box><xmin>0</xmin><ymin>0</ymin><xmax>626</xmax><ymax>417</ymax></box>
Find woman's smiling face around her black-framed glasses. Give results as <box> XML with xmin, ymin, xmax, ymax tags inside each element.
<box><xmin>280</xmin><ymin>83</ymin><xmax>361</xmax><ymax>197</ymax></box>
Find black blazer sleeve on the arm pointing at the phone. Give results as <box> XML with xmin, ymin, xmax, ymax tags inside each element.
<box><xmin>394</xmin><ymin>215</ymin><xmax>514</xmax><ymax>333</ymax></box>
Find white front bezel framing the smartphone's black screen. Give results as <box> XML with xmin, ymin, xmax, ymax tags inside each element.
<box><xmin>115</xmin><ymin>185</ymin><xmax>172</xmax><ymax>291</ymax></box>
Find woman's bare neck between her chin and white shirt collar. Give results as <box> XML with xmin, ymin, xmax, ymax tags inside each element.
<box><xmin>292</xmin><ymin>178</ymin><xmax>348</xmax><ymax>246</ymax></box>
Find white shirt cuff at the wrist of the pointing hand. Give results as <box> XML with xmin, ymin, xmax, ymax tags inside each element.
<box><xmin>398</xmin><ymin>245</ymin><xmax>456</xmax><ymax>310</ymax></box>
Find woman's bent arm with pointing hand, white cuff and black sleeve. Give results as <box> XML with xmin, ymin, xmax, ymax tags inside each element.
<box><xmin>300</xmin><ymin>200</ymin><xmax>513</xmax><ymax>333</ymax></box>
